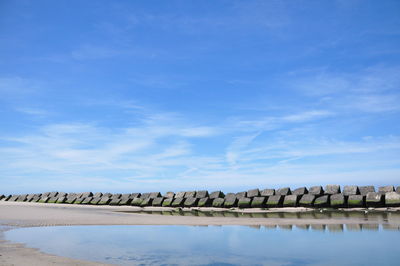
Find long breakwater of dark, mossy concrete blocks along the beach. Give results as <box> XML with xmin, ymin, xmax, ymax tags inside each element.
<box><xmin>0</xmin><ymin>185</ymin><xmax>400</xmax><ymax>208</ymax></box>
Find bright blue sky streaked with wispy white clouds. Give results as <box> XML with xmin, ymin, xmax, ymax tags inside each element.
<box><xmin>0</xmin><ymin>0</ymin><xmax>400</xmax><ymax>194</ymax></box>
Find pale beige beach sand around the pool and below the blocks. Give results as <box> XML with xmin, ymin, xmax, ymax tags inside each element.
<box><xmin>0</xmin><ymin>201</ymin><xmax>400</xmax><ymax>266</ymax></box>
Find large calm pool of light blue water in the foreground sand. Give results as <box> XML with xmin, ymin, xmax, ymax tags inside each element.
<box><xmin>5</xmin><ymin>224</ymin><xmax>400</xmax><ymax>265</ymax></box>
